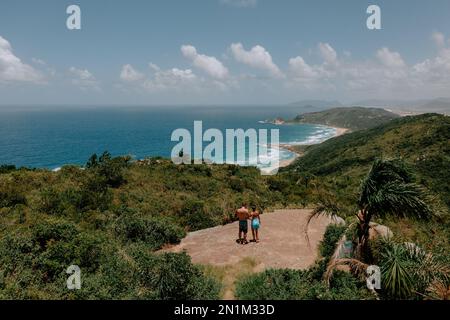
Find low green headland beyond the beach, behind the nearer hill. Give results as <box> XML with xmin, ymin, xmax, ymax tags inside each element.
<box><xmin>293</xmin><ymin>107</ymin><xmax>399</xmax><ymax>131</ymax></box>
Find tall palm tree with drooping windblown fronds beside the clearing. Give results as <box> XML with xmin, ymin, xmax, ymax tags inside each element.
<box><xmin>305</xmin><ymin>159</ymin><xmax>432</xmax><ymax>262</ymax></box>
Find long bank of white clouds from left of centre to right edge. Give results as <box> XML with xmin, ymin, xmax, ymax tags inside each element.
<box><xmin>118</xmin><ymin>35</ymin><xmax>450</xmax><ymax>99</ymax></box>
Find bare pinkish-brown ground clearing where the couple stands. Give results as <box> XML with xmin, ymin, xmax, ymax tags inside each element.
<box><xmin>167</xmin><ymin>209</ymin><xmax>338</xmax><ymax>271</ymax></box>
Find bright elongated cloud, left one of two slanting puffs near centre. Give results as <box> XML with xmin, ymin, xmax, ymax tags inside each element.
<box><xmin>181</xmin><ymin>45</ymin><xmax>228</xmax><ymax>79</ymax></box>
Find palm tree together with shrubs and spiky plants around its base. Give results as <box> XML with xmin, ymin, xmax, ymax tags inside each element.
<box><xmin>236</xmin><ymin>155</ymin><xmax>450</xmax><ymax>299</ymax></box>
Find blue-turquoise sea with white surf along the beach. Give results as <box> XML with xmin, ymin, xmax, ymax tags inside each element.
<box><xmin>0</xmin><ymin>106</ymin><xmax>335</xmax><ymax>169</ymax></box>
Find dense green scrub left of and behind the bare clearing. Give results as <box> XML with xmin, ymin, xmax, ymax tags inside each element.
<box><xmin>0</xmin><ymin>153</ymin><xmax>282</xmax><ymax>299</ymax></box>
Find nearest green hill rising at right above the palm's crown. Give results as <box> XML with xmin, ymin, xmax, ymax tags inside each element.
<box><xmin>285</xmin><ymin>114</ymin><xmax>450</xmax><ymax>208</ymax></box>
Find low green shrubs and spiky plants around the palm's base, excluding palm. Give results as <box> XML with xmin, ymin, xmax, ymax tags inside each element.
<box><xmin>236</xmin><ymin>220</ymin><xmax>450</xmax><ymax>300</ymax></box>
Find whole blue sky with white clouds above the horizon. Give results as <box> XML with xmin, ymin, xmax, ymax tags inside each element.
<box><xmin>0</xmin><ymin>0</ymin><xmax>450</xmax><ymax>105</ymax></box>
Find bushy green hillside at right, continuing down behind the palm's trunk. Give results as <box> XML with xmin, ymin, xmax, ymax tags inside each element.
<box><xmin>281</xmin><ymin>114</ymin><xmax>450</xmax><ymax>278</ymax></box>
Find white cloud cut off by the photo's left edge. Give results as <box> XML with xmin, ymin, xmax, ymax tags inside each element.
<box><xmin>0</xmin><ymin>36</ymin><xmax>44</xmax><ymax>83</ymax></box>
